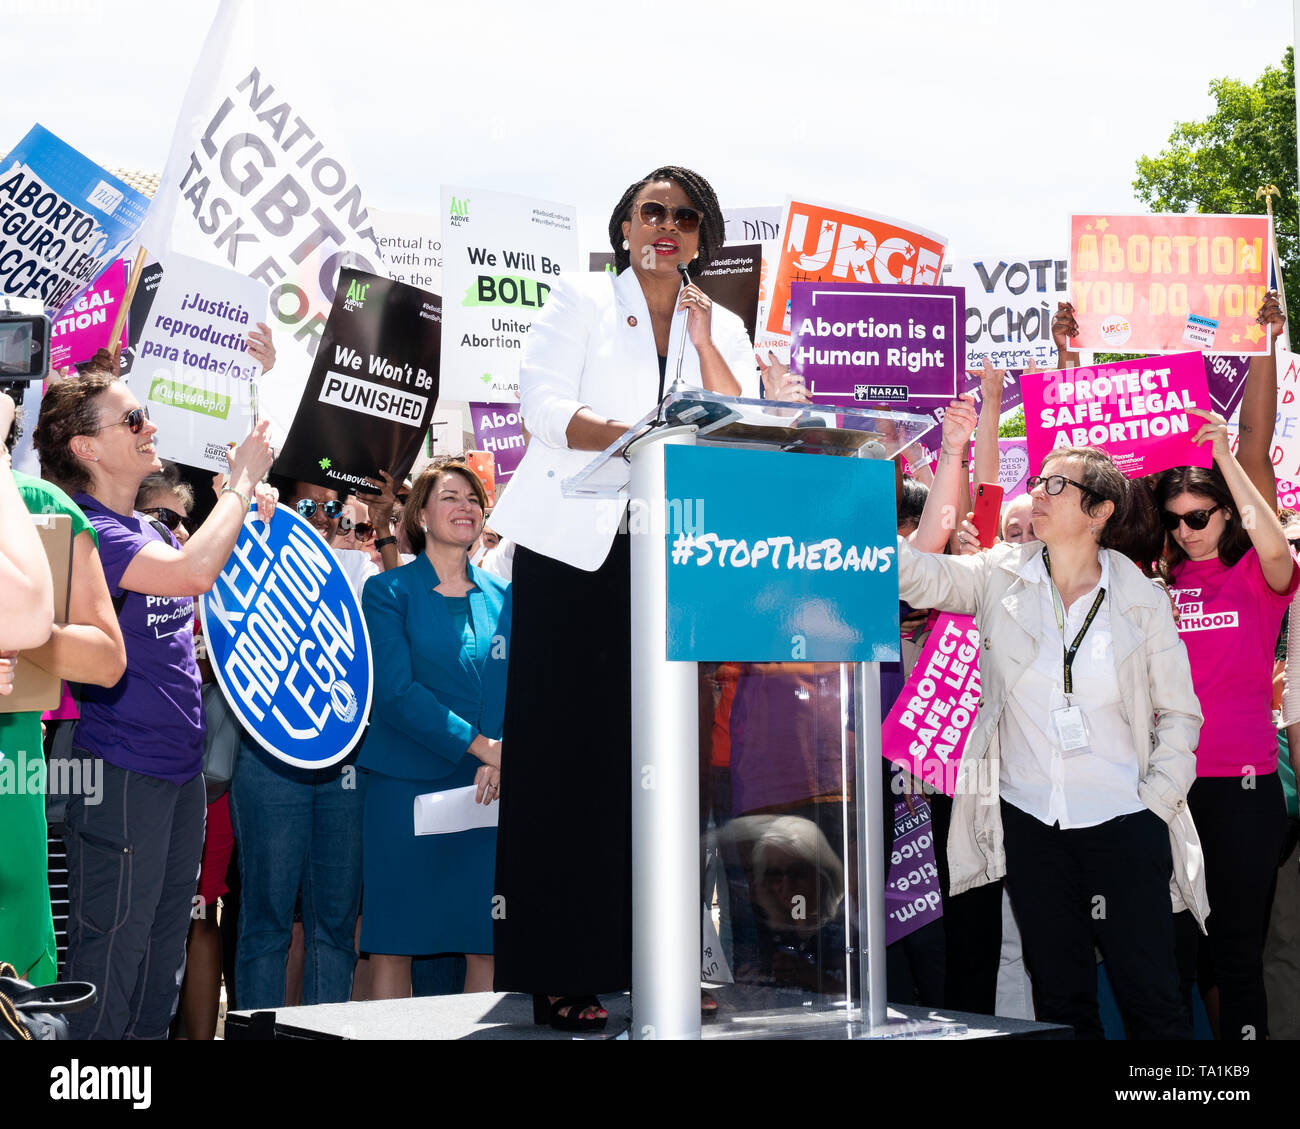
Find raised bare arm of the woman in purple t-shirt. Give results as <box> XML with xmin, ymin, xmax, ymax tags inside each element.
<box><xmin>122</xmin><ymin>420</ymin><xmax>277</xmax><ymax>596</ymax></box>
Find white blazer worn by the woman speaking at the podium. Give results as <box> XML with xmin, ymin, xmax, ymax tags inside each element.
<box><xmin>491</xmin><ymin>269</ymin><xmax>758</xmax><ymax>572</ymax></box>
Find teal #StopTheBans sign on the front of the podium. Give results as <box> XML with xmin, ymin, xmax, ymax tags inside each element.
<box><xmin>664</xmin><ymin>446</ymin><xmax>898</xmax><ymax>662</ymax></box>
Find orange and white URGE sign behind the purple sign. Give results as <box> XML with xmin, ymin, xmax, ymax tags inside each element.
<box><xmin>763</xmin><ymin>199</ymin><xmax>948</xmax><ymax>337</ymax></box>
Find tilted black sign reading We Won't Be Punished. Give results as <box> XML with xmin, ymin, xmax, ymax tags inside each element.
<box><xmin>276</xmin><ymin>267</ymin><xmax>442</xmax><ymax>490</ymax></box>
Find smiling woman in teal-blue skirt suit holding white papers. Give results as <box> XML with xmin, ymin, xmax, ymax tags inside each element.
<box><xmin>358</xmin><ymin>463</ymin><xmax>510</xmax><ymax>999</ymax></box>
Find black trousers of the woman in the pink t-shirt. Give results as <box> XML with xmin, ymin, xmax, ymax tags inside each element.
<box><xmin>1179</xmin><ymin>773</ymin><xmax>1287</xmax><ymax>1041</ymax></box>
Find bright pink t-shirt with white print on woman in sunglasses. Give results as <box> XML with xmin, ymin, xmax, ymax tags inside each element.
<box><xmin>1174</xmin><ymin>549</ymin><xmax>1300</xmax><ymax>777</ymax></box>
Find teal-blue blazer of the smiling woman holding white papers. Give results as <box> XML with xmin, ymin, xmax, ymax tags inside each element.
<box><xmin>358</xmin><ymin>553</ymin><xmax>511</xmax><ymax>780</ymax></box>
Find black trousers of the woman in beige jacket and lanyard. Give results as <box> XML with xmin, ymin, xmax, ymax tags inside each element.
<box><xmin>1002</xmin><ymin>800</ymin><xmax>1192</xmax><ymax>1039</ymax></box>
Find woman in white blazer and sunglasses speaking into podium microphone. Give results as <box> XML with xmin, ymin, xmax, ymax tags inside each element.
<box><xmin>493</xmin><ymin>165</ymin><xmax>758</xmax><ymax>1030</ymax></box>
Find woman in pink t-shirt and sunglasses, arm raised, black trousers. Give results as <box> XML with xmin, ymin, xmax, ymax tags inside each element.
<box><xmin>1156</xmin><ymin>408</ymin><xmax>1300</xmax><ymax>1039</ymax></box>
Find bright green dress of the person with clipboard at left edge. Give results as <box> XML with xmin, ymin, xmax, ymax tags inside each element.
<box><xmin>0</xmin><ymin>471</ymin><xmax>98</xmax><ymax>985</ymax></box>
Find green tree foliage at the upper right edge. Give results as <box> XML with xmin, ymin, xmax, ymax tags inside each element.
<box><xmin>1134</xmin><ymin>47</ymin><xmax>1300</xmax><ymax>297</ymax></box>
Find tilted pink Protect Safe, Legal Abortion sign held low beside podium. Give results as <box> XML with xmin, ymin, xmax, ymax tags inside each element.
<box><xmin>880</xmin><ymin>613</ymin><xmax>980</xmax><ymax>796</ymax></box>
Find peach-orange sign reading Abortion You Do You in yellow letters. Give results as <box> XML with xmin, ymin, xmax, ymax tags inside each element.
<box><xmin>1070</xmin><ymin>215</ymin><xmax>1271</xmax><ymax>352</ymax></box>
